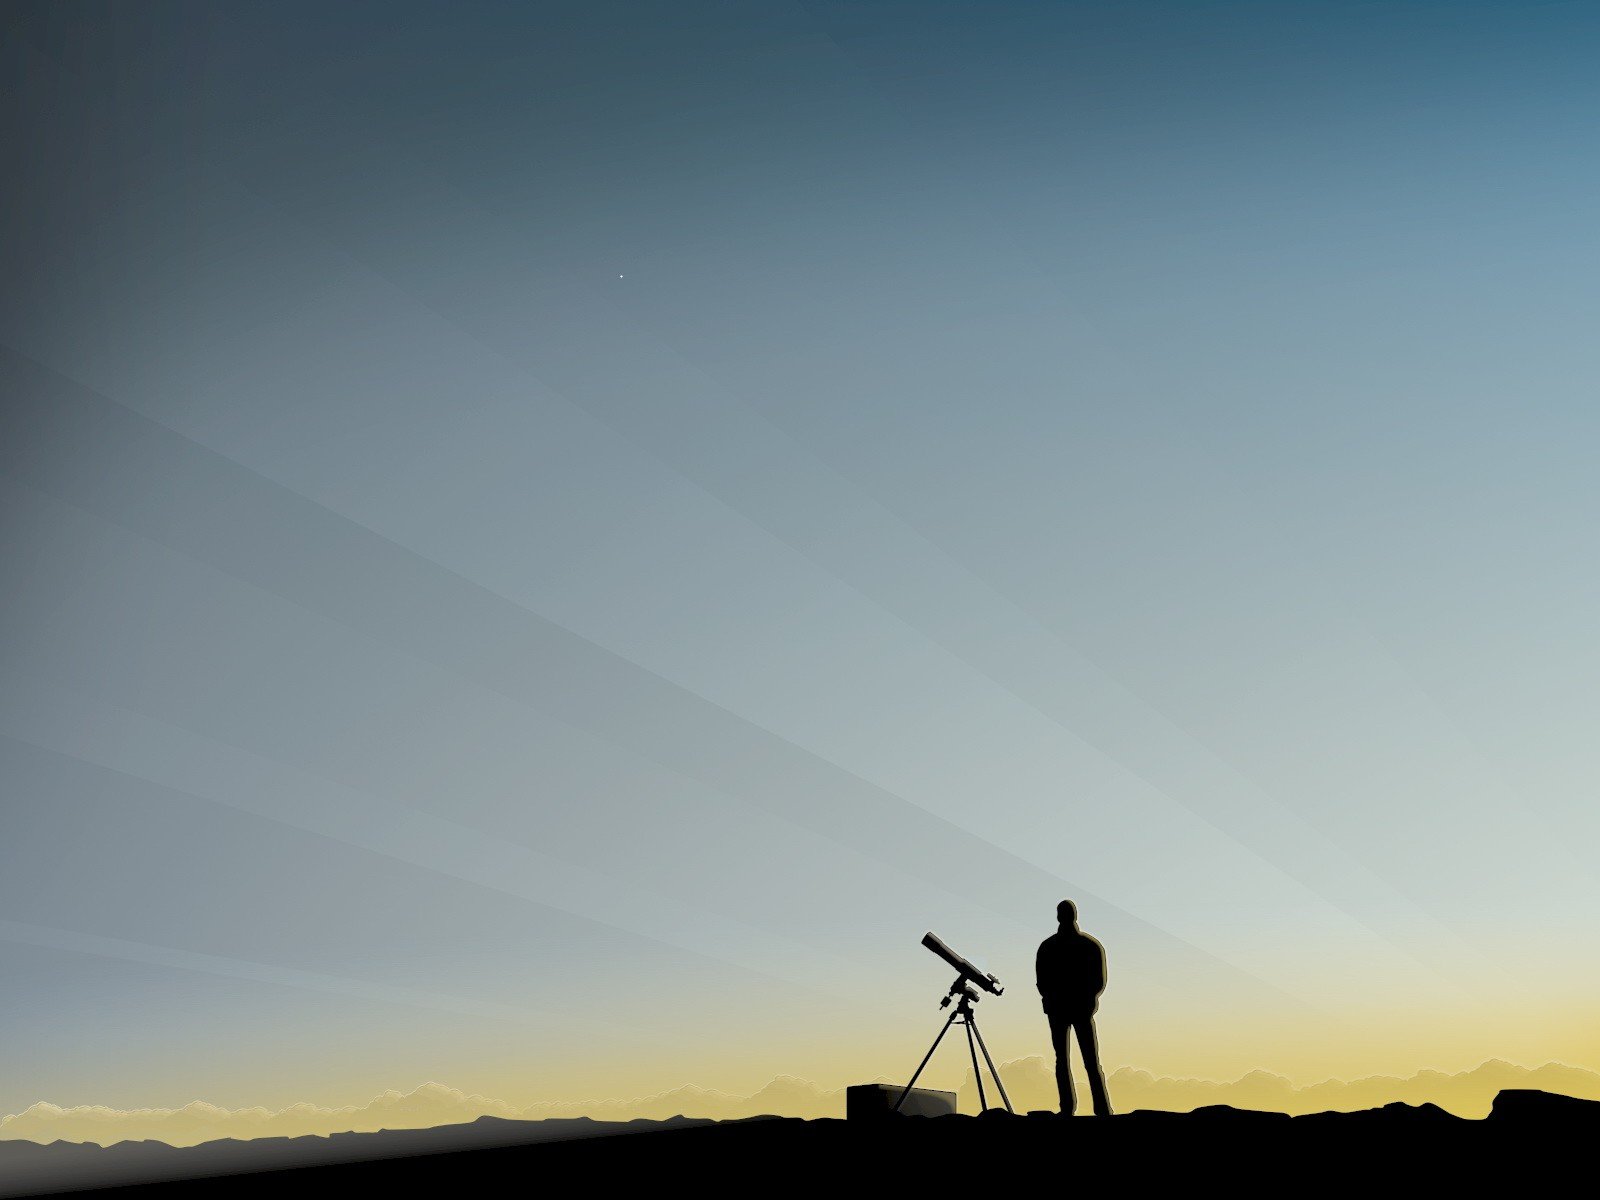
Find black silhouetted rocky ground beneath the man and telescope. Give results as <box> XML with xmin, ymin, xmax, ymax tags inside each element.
<box><xmin>0</xmin><ymin>1091</ymin><xmax>1600</xmax><ymax>1198</ymax></box>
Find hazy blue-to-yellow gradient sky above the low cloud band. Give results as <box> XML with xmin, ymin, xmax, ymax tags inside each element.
<box><xmin>0</xmin><ymin>0</ymin><xmax>1600</xmax><ymax>1112</ymax></box>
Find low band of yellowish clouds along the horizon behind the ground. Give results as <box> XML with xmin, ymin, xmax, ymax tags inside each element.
<box><xmin>0</xmin><ymin>1058</ymin><xmax>1600</xmax><ymax>1146</ymax></box>
